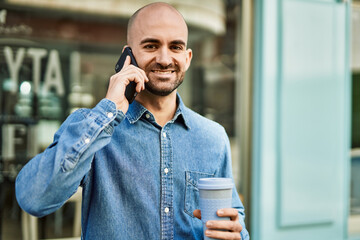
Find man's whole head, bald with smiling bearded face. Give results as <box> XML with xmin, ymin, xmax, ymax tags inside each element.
<box><xmin>128</xmin><ymin>3</ymin><xmax>192</xmax><ymax>96</ymax></box>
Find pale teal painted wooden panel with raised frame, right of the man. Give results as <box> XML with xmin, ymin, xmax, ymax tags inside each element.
<box><xmin>250</xmin><ymin>0</ymin><xmax>351</xmax><ymax>240</ymax></box>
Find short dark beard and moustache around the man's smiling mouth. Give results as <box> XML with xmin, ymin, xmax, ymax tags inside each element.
<box><xmin>145</xmin><ymin>64</ymin><xmax>185</xmax><ymax>96</ymax></box>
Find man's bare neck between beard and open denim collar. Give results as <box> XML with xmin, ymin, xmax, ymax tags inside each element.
<box><xmin>136</xmin><ymin>90</ymin><xmax>177</xmax><ymax>127</ymax></box>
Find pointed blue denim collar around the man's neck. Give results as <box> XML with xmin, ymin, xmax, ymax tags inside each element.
<box><xmin>126</xmin><ymin>93</ymin><xmax>190</xmax><ymax>129</ymax></box>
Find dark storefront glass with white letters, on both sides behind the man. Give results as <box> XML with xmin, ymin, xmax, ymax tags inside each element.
<box><xmin>0</xmin><ymin>0</ymin><xmax>243</xmax><ymax>239</ymax></box>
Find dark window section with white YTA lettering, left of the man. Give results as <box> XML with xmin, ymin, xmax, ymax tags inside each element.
<box><xmin>0</xmin><ymin>3</ymin><xmax>126</xmax><ymax>239</ymax></box>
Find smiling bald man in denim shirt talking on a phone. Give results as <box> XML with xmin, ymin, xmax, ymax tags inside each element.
<box><xmin>16</xmin><ymin>3</ymin><xmax>249</xmax><ymax>239</ymax></box>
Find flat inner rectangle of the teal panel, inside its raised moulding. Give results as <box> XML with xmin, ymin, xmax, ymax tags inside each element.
<box><xmin>279</xmin><ymin>1</ymin><xmax>346</xmax><ymax>227</ymax></box>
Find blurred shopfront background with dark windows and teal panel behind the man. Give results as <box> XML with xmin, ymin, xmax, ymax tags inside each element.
<box><xmin>0</xmin><ymin>0</ymin><xmax>360</xmax><ymax>240</ymax></box>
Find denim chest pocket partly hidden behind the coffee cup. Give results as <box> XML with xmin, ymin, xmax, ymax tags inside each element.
<box><xmin>184</xmin><ymin>171</ymin><xmax>214</xmax><ymax>217</ymax></box>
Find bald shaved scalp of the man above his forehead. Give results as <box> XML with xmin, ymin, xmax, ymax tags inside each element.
<box><xmin>127</xmin><ymin>2</ymin><xmax>188</xmax><ymax>45</ymax></box>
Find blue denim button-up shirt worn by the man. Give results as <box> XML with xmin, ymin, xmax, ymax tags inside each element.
<box><xmin>16</xmin><ymin>96</ymin><xmax>249</xmax><ymax>240</ymax></box>
